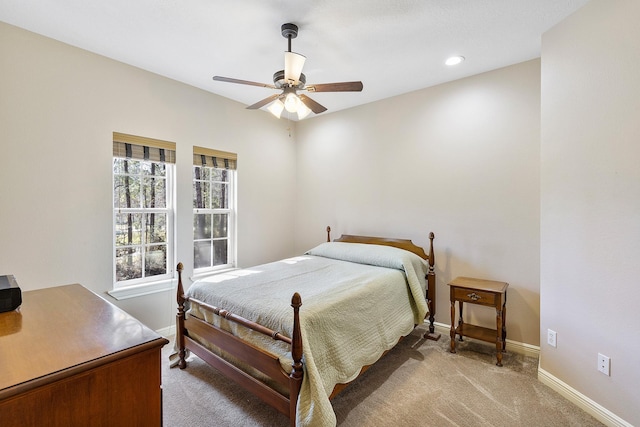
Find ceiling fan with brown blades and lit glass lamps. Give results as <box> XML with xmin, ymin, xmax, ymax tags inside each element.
<box><xmin>213</xmin><ymin>23</ymin><xmax>362</xmax><ymax>119</ymax></box>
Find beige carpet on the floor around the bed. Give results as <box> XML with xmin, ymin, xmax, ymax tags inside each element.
<box><xmin>162</xmin><ymin>328</ymin><xmax>602</xmax><ymax>427</ymax></box>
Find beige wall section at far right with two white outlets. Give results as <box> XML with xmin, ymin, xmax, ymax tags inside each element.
<box><xmin>540</xmin><ymin>0</ymin><xmax>640</xmax><ymax>425</ymax></box>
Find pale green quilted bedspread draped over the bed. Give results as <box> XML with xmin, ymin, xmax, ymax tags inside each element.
<box><xmin>187</xmin><ymin>242</ymin><xmax>428</xmax><ymax>427</ymax></box>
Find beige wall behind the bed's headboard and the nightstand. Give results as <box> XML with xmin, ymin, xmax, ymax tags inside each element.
<box><xmin>296</xmin><ymin>60</ymin><xmax>540</xmax><ymax>346</ymax></box>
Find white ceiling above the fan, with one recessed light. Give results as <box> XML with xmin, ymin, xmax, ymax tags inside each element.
<box><xmin>0</xmin><ymin>0</ymin><xmax>588</xmax><ymax>114</ymax></box>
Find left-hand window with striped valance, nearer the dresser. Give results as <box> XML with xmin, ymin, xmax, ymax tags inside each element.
<box><xmin>113</xmin><ymin>132</ymin><xmax>175</xmax><ymax>289</ymax></box>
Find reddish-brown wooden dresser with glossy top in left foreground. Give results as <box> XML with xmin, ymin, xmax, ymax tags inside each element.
<box><xmin>0</xmin><ymin>285</ymin><xmax>168</xmax><ymax>427</ymax></box>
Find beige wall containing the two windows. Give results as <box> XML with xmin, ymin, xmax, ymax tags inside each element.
<box><xmin>0</xmin><ymin>23</ymin><xmax>295</xmax><ymax>329</ymax></box>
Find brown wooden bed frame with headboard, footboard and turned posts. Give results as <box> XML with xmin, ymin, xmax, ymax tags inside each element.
<box><xmin>176</xmin><ymin>227</ymin><xmax>440</xmax><ymax>426</ymax></box>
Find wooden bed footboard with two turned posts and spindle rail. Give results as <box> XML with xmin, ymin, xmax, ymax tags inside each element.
<box><xmin>176</xmin><ymin>263</ymin><xmax>303</xmax><ymax>426</ymax></box>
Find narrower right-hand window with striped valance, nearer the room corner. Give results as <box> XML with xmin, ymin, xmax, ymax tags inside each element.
<box><xmin>193</xmin><ymin>147</ymin><xmax>237</xmax><ymax>274</ymax></box>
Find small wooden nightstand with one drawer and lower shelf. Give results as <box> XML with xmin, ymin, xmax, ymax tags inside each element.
<box><xmin>449</xmin><ymin>277</ymin><xmax>509</xmax><ymax>366</ymax></box>
